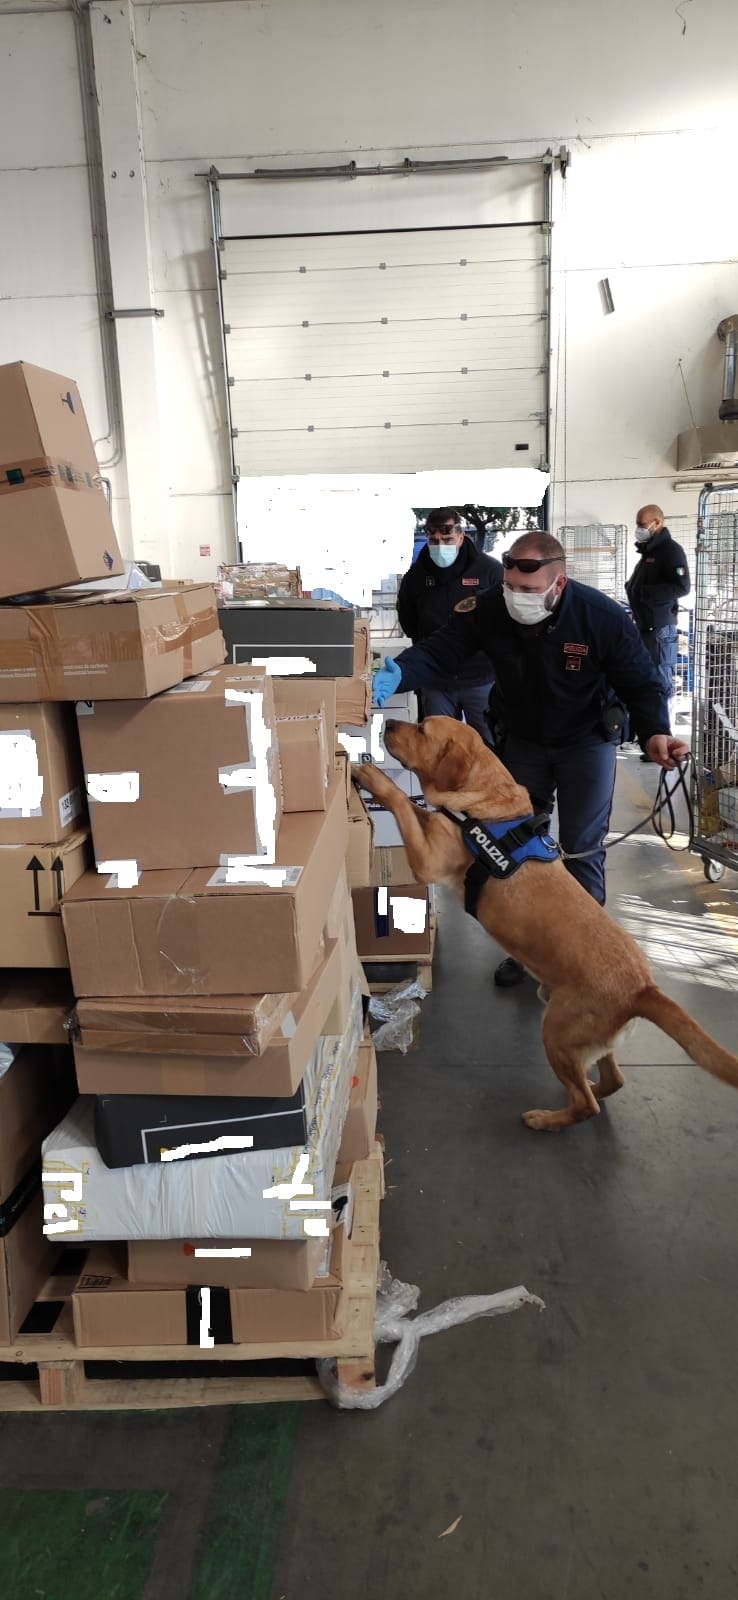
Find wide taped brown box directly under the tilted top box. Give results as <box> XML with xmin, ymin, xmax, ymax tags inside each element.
<box><xmin>0</xmin><ymin>579</ymin><xmax>226</xmax><ymax>702</ymax></box>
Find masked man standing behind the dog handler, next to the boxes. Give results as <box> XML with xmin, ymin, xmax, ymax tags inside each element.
<box><xmin>397</xmin><ymin>506</ymin><xmax>503</xmax><ymax>742</ymax></box>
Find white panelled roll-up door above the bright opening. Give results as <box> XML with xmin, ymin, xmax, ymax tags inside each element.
<box><xmin>219</xmin><ymin>221</ymin><xmax>549</xmax><ymax>477</ymax></box>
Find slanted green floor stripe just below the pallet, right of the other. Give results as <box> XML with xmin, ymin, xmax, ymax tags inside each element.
<box><xmin>191</xmin><ymin>1403</ymin><xmax>298</xmax><ymax>1600</ymax></box>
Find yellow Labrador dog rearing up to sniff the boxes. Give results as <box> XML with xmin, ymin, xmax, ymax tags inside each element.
<box><xmin>352</xmin><ymin>717</ymin><xmax>738</xmax><ymax>1130</ymax></box>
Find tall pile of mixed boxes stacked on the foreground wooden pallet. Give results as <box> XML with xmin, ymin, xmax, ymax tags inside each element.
<box><xmin>0</xmin><ymin>419</ymin><xmax>376</xmax><ymax>1346</ymax></box>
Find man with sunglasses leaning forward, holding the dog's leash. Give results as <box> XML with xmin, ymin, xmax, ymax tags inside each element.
<box><xmin>375</xmin><ymin>533</ymin><xmax>687</xmax><ymax>989</ymax></box>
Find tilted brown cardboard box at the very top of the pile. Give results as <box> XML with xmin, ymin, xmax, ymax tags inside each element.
<box><xmin>0</xmin><ymin>362</ymin><xmax>123</xmax><ymax>595</ymax></box>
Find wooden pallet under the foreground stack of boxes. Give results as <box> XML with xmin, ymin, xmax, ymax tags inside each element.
<box><xmin>0</xmin><ymin>1144</ymin><xmax>384</xmax><ymax>1411</ymax></box>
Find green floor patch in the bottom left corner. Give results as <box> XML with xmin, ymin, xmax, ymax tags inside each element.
<box><xmin>0</xmin><ymin>1490</ymin><xmax>168</xmax><ymax>1600</ymax></box>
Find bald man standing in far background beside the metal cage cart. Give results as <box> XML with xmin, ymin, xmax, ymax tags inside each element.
<box><xmin>626</xmin><ymin>506</ymin><xmax>692</xmax><ymax>762</ymax></box>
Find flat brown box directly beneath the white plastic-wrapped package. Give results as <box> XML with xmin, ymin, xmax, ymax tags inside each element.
<box><xmin>128</xmin><ymin>1238</ymin><xmax>325</xmax><ymax>1294</ymax></box>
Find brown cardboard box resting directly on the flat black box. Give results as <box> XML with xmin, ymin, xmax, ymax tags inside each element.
<box><xmin>74</xmin><ymin>944</ymin><xmax>341</xmax><ymax>1099</ymax></box>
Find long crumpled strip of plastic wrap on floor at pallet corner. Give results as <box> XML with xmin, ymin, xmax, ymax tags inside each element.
<box><xmin>317</xmin><ymin>1261</ymin><xmax>544</xmax><ymax>1411</ymax></box>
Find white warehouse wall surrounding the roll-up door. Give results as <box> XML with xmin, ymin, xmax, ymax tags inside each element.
<box><xmin>0</xmin><ymin>0</ymin><xmax>738</xmax><ymax>576</ymax></box>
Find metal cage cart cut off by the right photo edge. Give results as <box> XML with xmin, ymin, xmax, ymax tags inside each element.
<box><xmin>692</xmin><ymin>483</ymin><xmax>738</xmax><ymax>883</ymax></box>
